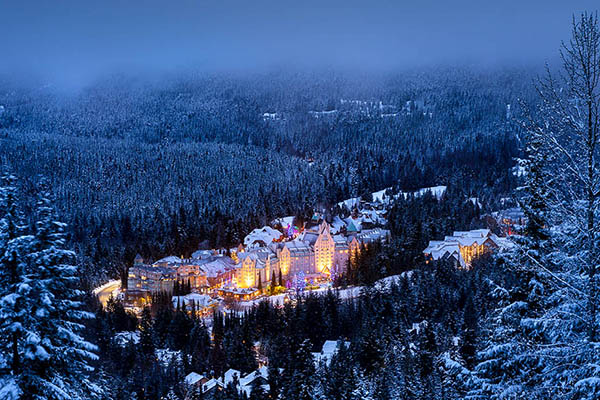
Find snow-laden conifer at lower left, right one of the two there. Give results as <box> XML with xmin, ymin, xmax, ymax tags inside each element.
<box><xmin>21</xmin><ymin>193</ymin><xmax>100</xmax><ymax>399</ymax></box>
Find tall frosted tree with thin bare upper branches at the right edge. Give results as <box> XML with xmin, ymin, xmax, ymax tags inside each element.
<box><xmin>526</xmin><ymin>13</ymin><xmax>600</xmax><ymax>399</ymax></box>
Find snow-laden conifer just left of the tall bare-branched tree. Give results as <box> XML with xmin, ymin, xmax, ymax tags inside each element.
<box><xmin>468</xmin><ymin>95</ymin><xmax>552</xmax><ymax>399</ymax></box>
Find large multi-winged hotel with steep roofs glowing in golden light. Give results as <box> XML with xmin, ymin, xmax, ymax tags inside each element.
<box><xmin>128</xmin><ymin>214</ymin><xmax>389</xmax><ymax>300</ymax></box>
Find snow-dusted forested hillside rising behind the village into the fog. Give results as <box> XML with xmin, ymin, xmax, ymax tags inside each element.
<box><xmin>0</xmin><ymin>70</ymin><xmax>530</xmax><ymax>279</ymax></box>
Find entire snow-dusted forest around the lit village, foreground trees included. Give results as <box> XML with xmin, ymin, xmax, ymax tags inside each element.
<box><xmin>0</xmin><ymin>7</ymin><xmax>600</xmax><ymax>400</ymax></box>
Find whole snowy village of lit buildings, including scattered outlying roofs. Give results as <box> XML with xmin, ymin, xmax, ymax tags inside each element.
<box><xmin>95</xmin><ymin>186</ymin><xmax>525</xmax><ymax>398</ymax></box>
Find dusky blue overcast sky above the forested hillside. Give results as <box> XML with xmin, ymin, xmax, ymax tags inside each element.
<box><xmin>0</xmin><ymin>0</ymin><xmax>598</xmax><ymax>81</ymax></box>
